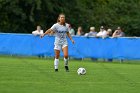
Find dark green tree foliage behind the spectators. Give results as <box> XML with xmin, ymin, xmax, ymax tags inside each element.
<box><xmin>0</xmin><ymin>0</ymin><xmax>140</xmax><ymax>36</ymax></box>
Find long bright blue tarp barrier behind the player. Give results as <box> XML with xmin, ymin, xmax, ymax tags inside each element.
<box><xmin>0</xmin><ymin>33</ymin><xmax>140</xmax><ymax>59</ymax></box>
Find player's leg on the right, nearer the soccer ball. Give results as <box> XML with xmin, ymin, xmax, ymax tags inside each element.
<box><xmin>62</xmin><ymin>45</ymin><xmax>69</xmax><ymax>71</ymax></box>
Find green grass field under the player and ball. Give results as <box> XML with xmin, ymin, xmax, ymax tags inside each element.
<box><xmin>0</xmin><ymin>56</ymin><xmax>140</xmax><ymax>93</ymax></box>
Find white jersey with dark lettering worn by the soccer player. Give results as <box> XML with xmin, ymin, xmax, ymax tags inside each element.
<box><xmin>51</xmin><ymin>23</ymin><xmax>68</xmax><ymax>45</ymax></box>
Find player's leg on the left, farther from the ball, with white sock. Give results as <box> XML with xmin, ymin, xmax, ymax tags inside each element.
<box><xmin>54</xmin><ymin>45</ymin><xmax>60</xmax><ymax>72</ymax></box>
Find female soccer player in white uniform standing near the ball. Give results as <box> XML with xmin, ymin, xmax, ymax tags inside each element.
<box><xmin>41</xmin><ymin>14</ymin><xmax>74</xmax><ymax>72</ymax></box>
